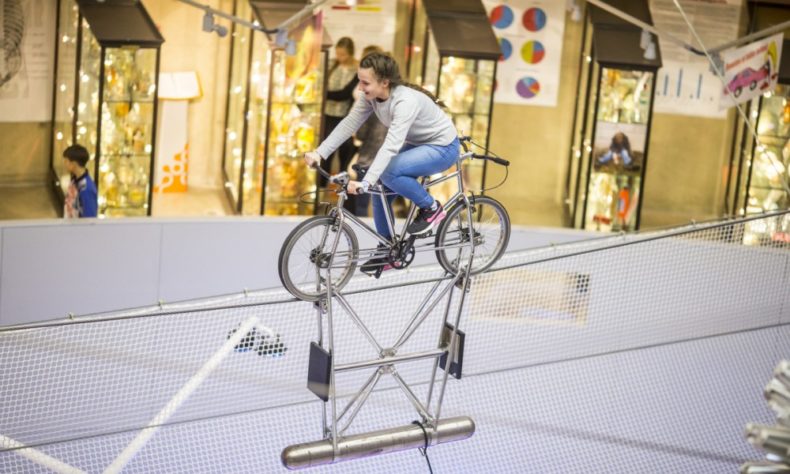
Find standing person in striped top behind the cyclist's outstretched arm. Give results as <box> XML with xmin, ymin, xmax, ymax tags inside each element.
<box><xmin>319</xmin><ymin>36</ymin><xmax>359</xmax><ymax>187</ymax></box>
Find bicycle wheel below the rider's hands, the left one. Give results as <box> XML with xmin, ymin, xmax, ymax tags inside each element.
<box><xmin>277</xmin><ymin>216</ymin><xmax>359</xmax><ymax>301</ymax></box>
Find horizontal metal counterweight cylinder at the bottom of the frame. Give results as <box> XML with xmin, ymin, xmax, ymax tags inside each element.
<box><xmin>281</xmin><ymin>416</ymin><xmax>475</xmax><ymax>469</ymax></box>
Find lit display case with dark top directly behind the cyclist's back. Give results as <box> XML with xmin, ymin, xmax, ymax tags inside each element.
<box><xmin>407</xmin><ymin>0</ymin><xmax>502</xmax><ymax>196</ymax></box>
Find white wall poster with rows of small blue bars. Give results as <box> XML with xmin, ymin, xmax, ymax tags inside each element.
<box><xmin>650</xmin><ymin>0</ymin><xmax>743</xmax><ymax>118</ymax></box>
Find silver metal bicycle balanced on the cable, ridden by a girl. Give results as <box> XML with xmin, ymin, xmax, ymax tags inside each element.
<box><xmin>278</xmin><ymin>137</ymin><xmax>510</xmax><ymax>301</ymax></box>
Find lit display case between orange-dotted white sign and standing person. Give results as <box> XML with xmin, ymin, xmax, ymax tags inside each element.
<box><xmin>223</xmin><ymin>2</ymin><xmax>326</xmax><ymax>215</ymax></box>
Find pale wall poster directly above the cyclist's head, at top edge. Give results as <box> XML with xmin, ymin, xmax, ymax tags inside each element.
<box><xmin>323</xmin><ymin>0</ymin><xmax>396</xmax><ymax>59</ymax></box>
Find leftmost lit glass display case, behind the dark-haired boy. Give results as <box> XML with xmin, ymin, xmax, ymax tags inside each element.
<box><xmin>51</xmin><ymin>0</ymin><xmax>164</xmax><ymax>217</ymax></box>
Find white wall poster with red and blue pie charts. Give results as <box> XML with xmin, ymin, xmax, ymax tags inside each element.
<box><xmin>483</xmin><ymin>0</ymin><xmax>565</xmax><ymax>107</ymax></box>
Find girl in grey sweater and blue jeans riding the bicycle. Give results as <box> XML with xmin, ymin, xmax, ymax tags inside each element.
<box><xmin>304</xmin><ymin>53</ymin><xmax>459</xmax><ymax>272</ymax></box>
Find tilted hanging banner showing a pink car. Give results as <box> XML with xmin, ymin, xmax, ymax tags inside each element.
<box><xmin>719</xmin><ymin>33</ymin><xmax>784</xmax><ymax>109</ymax></box>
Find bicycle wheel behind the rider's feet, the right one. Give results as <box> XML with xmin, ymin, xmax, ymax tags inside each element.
<box><xmin>436</xmin><ymin>196</ymin><xmax>510</xmax><ymax>275</ymax></box>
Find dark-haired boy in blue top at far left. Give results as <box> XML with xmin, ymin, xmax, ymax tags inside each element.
<box><xmin>63</xmin><ymin>145</ymin><xmax>99</xmax><ymax>219</ymax></box>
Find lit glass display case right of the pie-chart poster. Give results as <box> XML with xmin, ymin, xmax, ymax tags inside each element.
<box><xmin>565</xmin><ymin>0</ymin><xmax>661</xmax><ymax>231</ymax></box>
